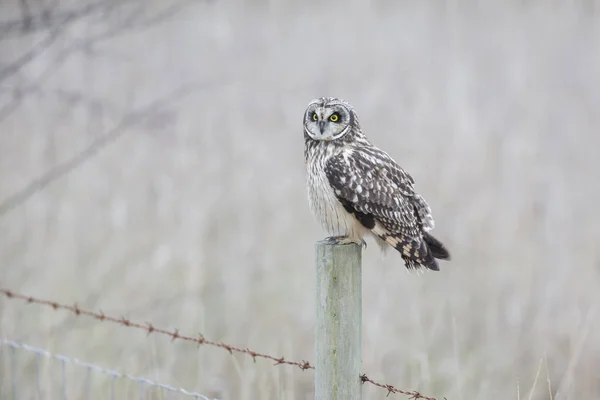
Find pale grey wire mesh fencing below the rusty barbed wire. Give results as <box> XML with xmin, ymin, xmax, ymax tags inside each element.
<box><xmin>0</xmin><ymin>339</ymin><xmax>214</xmax><ymax>400</ymax></box>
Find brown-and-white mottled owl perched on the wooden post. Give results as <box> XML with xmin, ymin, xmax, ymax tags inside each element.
<box><xmin>304</xmin><ymin>97</ymin><xmax>450</xmax><ymax>271</ymax></box>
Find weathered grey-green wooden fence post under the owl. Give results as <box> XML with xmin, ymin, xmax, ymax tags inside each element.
<box><xmin>315</xmin><ymin>241</ymin><xmax>362</xmax><ymax>400</ymax></box>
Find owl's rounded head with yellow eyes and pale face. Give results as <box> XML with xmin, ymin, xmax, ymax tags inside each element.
<box><xmin>304</xmin><ymin>97</ymin><xmax>358</xmax><ymax>141</ymax></box>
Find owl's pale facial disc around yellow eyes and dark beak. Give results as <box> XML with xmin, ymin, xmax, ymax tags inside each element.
<box><xmin>304</xmin><ymin>102</ymin><xmax>351</xmax><ymax>141</ymax></box>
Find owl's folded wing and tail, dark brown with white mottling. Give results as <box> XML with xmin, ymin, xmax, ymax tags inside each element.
<box><xmin>325</xmin><ymin>147</ymin><xmax>449</xmax><ymax>270</ymax></box>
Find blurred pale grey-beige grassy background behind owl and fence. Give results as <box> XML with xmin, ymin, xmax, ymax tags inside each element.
<box><xmin>0</xmin><ymin>0</ymin><xmax>600</xmax><ymax>400</ymax></box>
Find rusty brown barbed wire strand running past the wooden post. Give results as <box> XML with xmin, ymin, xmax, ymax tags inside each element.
<box><xmin>0</xmin><ymin>288</ymin><xmax>446</xmax><ymax>400</ymax></box>
